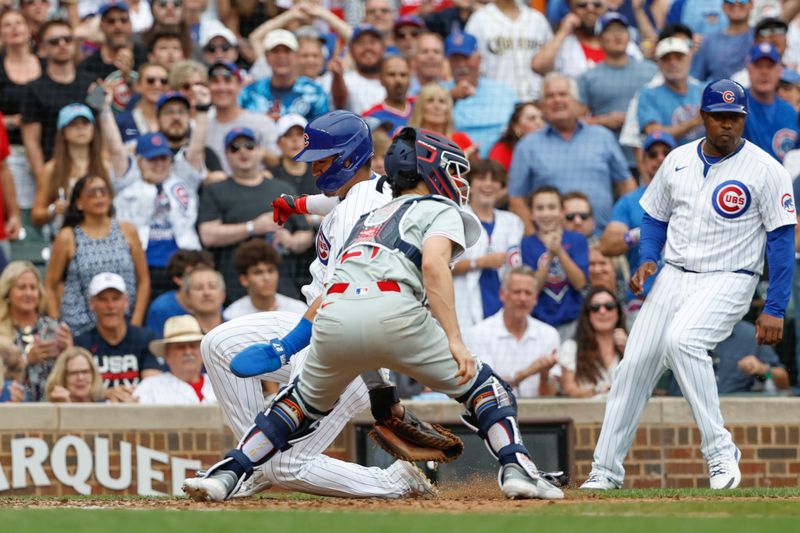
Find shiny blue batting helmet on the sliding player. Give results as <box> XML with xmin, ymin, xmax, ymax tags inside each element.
<box><xmin>294</xmin><ymin>111</ymin><xmax>374</xmax><ymax>192</ymax></box>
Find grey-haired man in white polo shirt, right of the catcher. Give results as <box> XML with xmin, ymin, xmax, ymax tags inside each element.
<box><xmin>464</xmin><ymin>266</ymin><xmax>560</xmax><ymax>398</ymax></box>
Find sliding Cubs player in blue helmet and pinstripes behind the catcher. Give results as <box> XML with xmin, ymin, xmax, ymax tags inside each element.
<box><xmin>187</xmin><ymin>111</ymin><xmax>456</xmax><ymax>498</ymax></box>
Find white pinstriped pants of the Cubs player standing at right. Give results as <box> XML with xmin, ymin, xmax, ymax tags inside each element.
<box><xmin>592</xmin><ymin>265</ymin><xmax>758</xmax><ymax>485</ymax></box>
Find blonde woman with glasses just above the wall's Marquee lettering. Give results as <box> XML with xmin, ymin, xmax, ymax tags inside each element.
<box><xmin>47</xmin><ymin>346</ymin><xmax>104</xmax><ymax>403</ymax></box>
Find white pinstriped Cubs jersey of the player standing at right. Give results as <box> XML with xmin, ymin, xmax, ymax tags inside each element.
<box><xmin>640</xmin><ymin>139</ymin><xmax>797</xmax><ymax>274</ymax></box>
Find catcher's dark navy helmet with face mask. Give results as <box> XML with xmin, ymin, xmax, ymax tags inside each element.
<box><xmin>384</xmin><ymin>128</ymin><xmax>469</xmax><ymax>206</ymax></box>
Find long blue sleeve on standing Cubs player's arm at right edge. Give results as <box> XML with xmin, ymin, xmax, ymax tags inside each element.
<box><xmin>764</xmin><ymin>224</ymin><xmax>794</xmax><ymax>318</ymax></box>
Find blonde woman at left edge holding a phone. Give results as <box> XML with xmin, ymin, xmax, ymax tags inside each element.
<box><xmin>0</xmin><ymin>261</ymin><xmax>72</xmax><ymax>402</ymax></box>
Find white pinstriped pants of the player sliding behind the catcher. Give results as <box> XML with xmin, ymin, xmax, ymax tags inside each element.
<box><xmin>200</xmin><ymin>312</ymin><xmax>409</xmax><ymax>498</ymax></box>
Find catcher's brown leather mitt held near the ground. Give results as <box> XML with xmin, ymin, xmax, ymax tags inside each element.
<box><xmin>369</xmin><ymin>408</ymin><xmax>464</xmax><ymax>463</ymax></box>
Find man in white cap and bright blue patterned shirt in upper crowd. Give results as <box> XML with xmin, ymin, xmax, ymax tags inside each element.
<box><xmin>239</xmin><ymin>29</ymin><xmax>328</xmax><ymax>120</ymax></box>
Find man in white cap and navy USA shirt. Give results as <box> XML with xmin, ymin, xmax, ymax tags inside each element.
<box><xmin>75</xmin><ymin>272</ymin><xmax>161</xmax><ymax>402</ymax></box>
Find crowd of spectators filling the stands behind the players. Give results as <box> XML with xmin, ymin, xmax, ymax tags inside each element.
<box><xmin>0</xmin><ymin>0</ymin><xmax>800</xmax><ymax>404</ymax></box>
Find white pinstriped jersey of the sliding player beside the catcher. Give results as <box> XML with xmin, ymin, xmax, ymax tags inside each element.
<box><xmin>302</xmin><ymin>174</ymin><xmax>392</xmax><ymax>305</ymax></box>
